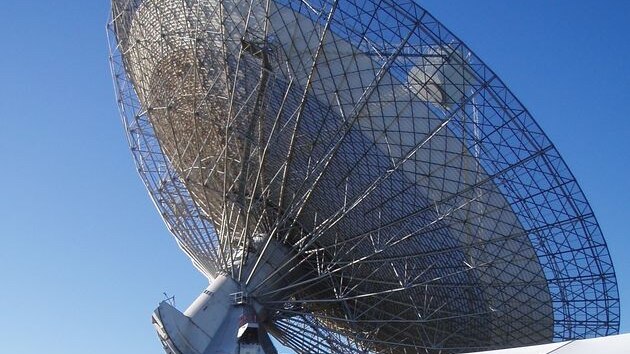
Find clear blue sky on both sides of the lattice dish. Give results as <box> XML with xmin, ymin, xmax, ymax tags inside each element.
<box><xmin>0</xmin><ymin>0</ymin><xmax>630</xmax><ymax>354</ymax></box>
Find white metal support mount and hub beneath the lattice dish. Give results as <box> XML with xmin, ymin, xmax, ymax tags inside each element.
<box><xmin>152</xmin><ymin>239</ymin><xmax>302</xmax><ymax>354</ymax></box>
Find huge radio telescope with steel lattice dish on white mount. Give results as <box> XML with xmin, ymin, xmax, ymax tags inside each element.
<box><xmin>109</xmin><ymin>0</ymin><xmax>619</xmax><ymax>354</ymax></box>
